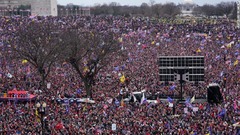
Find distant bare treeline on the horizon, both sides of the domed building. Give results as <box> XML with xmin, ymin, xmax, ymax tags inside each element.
<box><xmin>91</xmin><ymin>1</ymin><xmax>237</xmax><ymax>19</ymax></box>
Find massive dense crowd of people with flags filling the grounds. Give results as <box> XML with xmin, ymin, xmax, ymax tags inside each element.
<box><xmin>0</xmin><ymin>16</ymin><xmax>240</xmax><ymax>135</ymax></box>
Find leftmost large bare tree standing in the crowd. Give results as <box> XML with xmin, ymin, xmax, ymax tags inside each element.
<box><xmin>10</xmin><ymin>21</ymin><xmax>62</xmax><ymax>87</ymax></box>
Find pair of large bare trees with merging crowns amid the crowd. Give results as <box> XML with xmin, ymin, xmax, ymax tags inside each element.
<box><xmin>9</xmin><ymin>22</ymin><xmax>121</xmax><ymax>97</ymax></box>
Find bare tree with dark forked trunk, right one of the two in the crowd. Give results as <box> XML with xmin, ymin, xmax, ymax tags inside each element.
<box><xmin>62</xmin><ymin>29</ymin><xmax>121</xmax><ymax>98</ymax></box>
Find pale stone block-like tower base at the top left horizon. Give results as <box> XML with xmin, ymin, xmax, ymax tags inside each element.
<box><xmin>31</xmin><ymin>0</ymin><xmax>58</xmax><ymax>16</ymax></box>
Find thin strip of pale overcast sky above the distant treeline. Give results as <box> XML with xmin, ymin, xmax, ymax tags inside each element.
<box><xmin>57</xmin><ymin>0</ymin><xmax>236</xmax><ymax>6</ymax></box>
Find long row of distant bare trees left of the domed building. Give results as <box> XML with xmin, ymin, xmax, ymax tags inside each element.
<box><xmin>91</xmin><ymin>2</ymin><xmax>181</xmax><ymax>16</ymax></box>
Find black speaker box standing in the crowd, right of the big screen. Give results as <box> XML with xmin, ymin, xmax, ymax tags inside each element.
<box><xmin>207</xmin><ymin>84</ymin><xmax>223</xmax><ymax>104</ymax></box>
